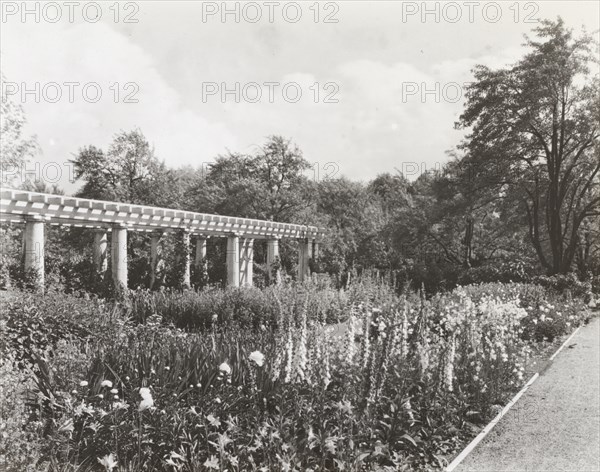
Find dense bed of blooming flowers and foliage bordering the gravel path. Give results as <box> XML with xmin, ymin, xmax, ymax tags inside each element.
<box><xmin>0</xmin><ymin>284</ymin><xmax>588</xmax><ymax>471</ymax></box>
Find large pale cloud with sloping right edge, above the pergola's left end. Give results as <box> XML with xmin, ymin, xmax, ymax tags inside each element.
<box><xmin>1</xmin><ymin>22</ymin><xmax>238</xmax><ymax>190</ymax></box>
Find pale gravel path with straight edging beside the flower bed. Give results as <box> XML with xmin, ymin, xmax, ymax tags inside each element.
<box><xmin>455</xmin><ymin>318</ymin><xmax>600</xmax><ymax>472</ymax></box>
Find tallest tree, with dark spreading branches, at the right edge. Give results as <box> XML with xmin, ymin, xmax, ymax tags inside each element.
<box><xmin>458</xmin><ymin>19</ymin><xmax>600</xmax><ymax>274</ymax></box>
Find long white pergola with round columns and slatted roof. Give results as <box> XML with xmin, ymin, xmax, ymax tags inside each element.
<box><xmin>0</xmin><ymin>189</ymin><xmax>324</xmax><ymax>287</ymax></box>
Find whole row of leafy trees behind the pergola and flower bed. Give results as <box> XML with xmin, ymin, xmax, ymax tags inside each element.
<box><xmin>2</xmin><ymin>19</ymin><xmax>600</xmax><ymax>290</ymax></box>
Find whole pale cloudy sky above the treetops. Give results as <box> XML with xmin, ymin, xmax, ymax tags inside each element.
<box><xmin>0</xmin><ymin>1</ymin><xmax>600</xmax><ymax>191</ymax></box>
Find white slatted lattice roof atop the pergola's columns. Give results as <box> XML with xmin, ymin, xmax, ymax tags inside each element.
<box><xmin>0</xmin><ymin>189</ymin><xmax>324</xmax><ymax>239</ymax></box>
